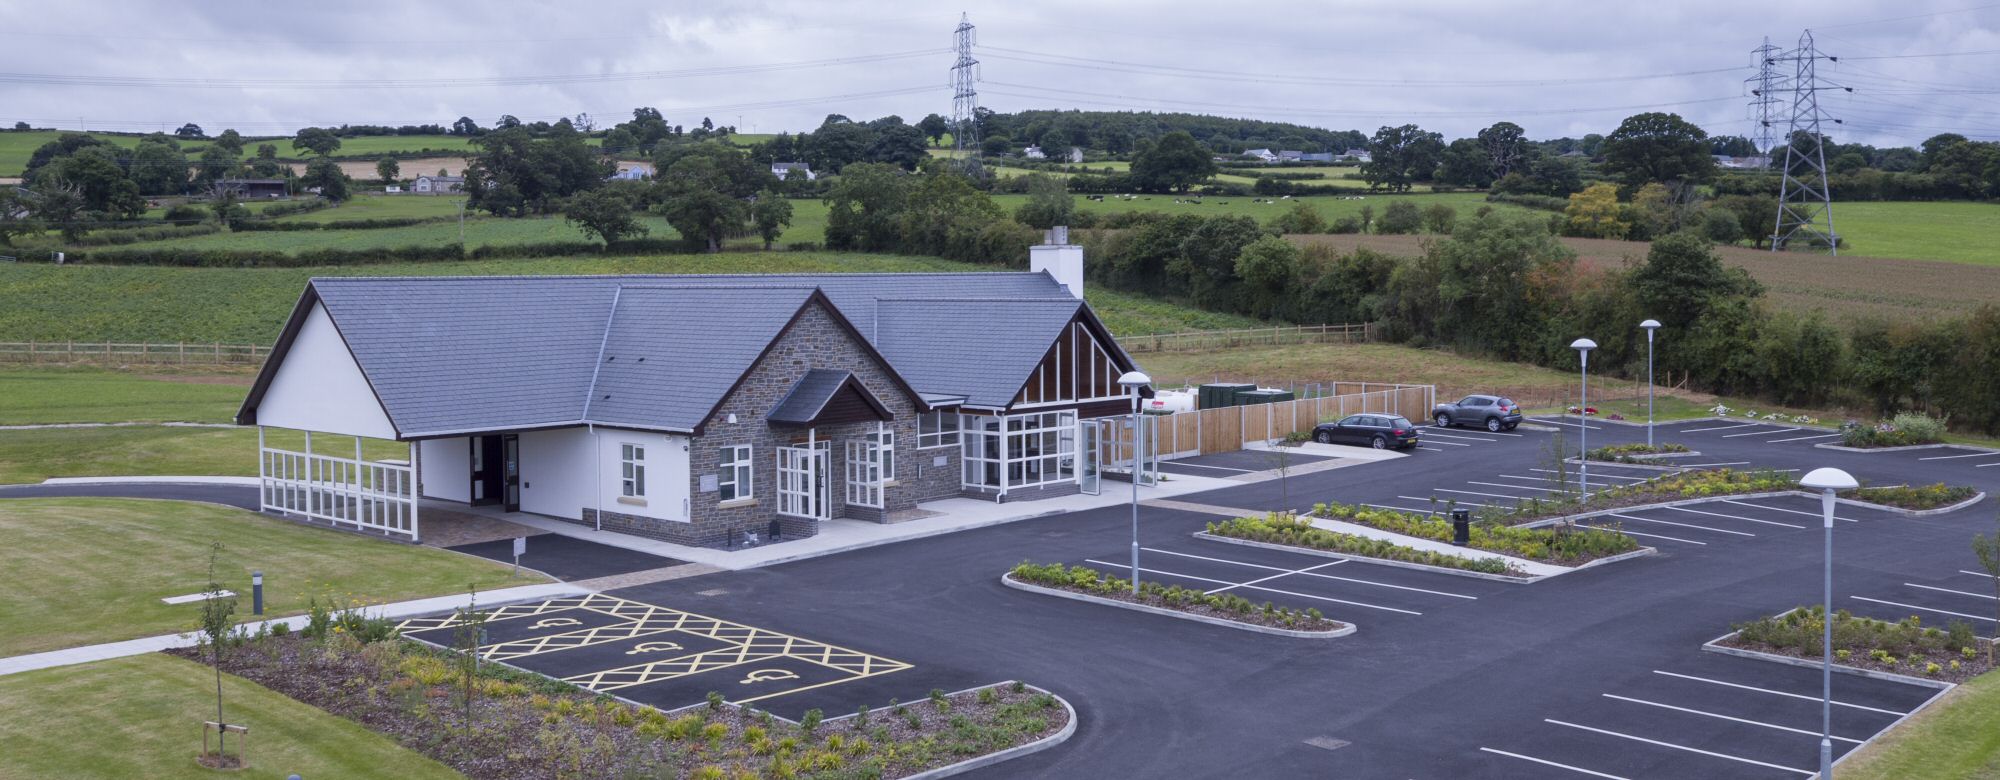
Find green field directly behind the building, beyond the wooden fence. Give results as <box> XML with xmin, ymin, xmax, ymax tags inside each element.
<box><xmin>0</xmin><ymin>251</ymin><xmax>1250</xmax><ymax>344</ymax></box>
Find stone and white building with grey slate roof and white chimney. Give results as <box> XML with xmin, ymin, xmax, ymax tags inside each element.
<box><xmin>236</xmin><ymin>238</ymin><xmax>1136</xmax><ymax>548</ymax></box>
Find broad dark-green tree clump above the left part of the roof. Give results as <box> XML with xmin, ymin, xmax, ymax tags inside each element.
<box><xmin>466</xmin><ymin>126</ymin><xmax>612</xmax><ymax>216</ymax></box>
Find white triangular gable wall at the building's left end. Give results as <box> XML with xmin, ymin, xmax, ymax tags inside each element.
<box><xmin>256</xmin><ymin>304</ymin><xmax>396</xmax><ymax>440</ymax></box>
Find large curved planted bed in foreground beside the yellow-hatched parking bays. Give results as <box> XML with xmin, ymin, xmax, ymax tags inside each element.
<box><xmin>170</xmin><ymin>632</ymin><xmax>1068</xmax><ymax>780</ymax></box>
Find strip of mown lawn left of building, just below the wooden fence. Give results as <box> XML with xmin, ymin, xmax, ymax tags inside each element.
<box><xmin>0</xmin><ymin>366</ymin><xmax>252</xmax><ymax>426</ymax></box>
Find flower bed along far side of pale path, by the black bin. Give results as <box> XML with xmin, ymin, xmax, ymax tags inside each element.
<box><xmin>1312</xmin><ymin>504</ymin><xmax>1640</xmax><ymax>566</ymax></box>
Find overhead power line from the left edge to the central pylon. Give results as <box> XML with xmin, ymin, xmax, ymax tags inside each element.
<box><xmin>0</xmin><ymin>48</ymin><xmax>948</xmax><ymax>90</ymax></box>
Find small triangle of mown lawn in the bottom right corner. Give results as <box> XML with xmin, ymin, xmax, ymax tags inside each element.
<box><xmin>1834</xmin><ymin>672</ymin><xmax>2000</xmax><ymax>780</ymax></box>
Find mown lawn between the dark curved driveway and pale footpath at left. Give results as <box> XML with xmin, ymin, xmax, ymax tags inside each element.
<box><xmin>0</xmin><ymin>498</ymin><xmax>548</xmax><ymax>656</ymax></box>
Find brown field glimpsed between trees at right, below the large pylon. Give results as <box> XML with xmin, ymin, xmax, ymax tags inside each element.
<box><xmin>1292</xmin><ymin>229</ymin><xmax>2000</xmax><ymax>320</ymax></box>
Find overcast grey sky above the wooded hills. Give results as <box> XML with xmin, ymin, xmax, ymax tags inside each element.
<box><xmin>0</xmin><ymin>0</ymin><xmax>2000</xmax><ymax>144</ymax></box>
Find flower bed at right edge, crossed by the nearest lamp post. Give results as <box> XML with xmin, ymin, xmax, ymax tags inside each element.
<box><xmin>1718</xmin><ymin>606</ymin><xmax>1994</xmax><ymax>682</ymax></box>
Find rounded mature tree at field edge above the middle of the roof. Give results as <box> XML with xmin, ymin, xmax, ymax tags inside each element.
<box><xmin>654</xmin><ymin>142</ymin><xmax>776</xmax><ymax>252</ymax></box>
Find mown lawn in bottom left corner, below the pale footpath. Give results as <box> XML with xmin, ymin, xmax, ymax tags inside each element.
<box><xmin>0</xmin><ymin>654</ymin><xmax>460</xmax><ymax>780</ymax></box>
